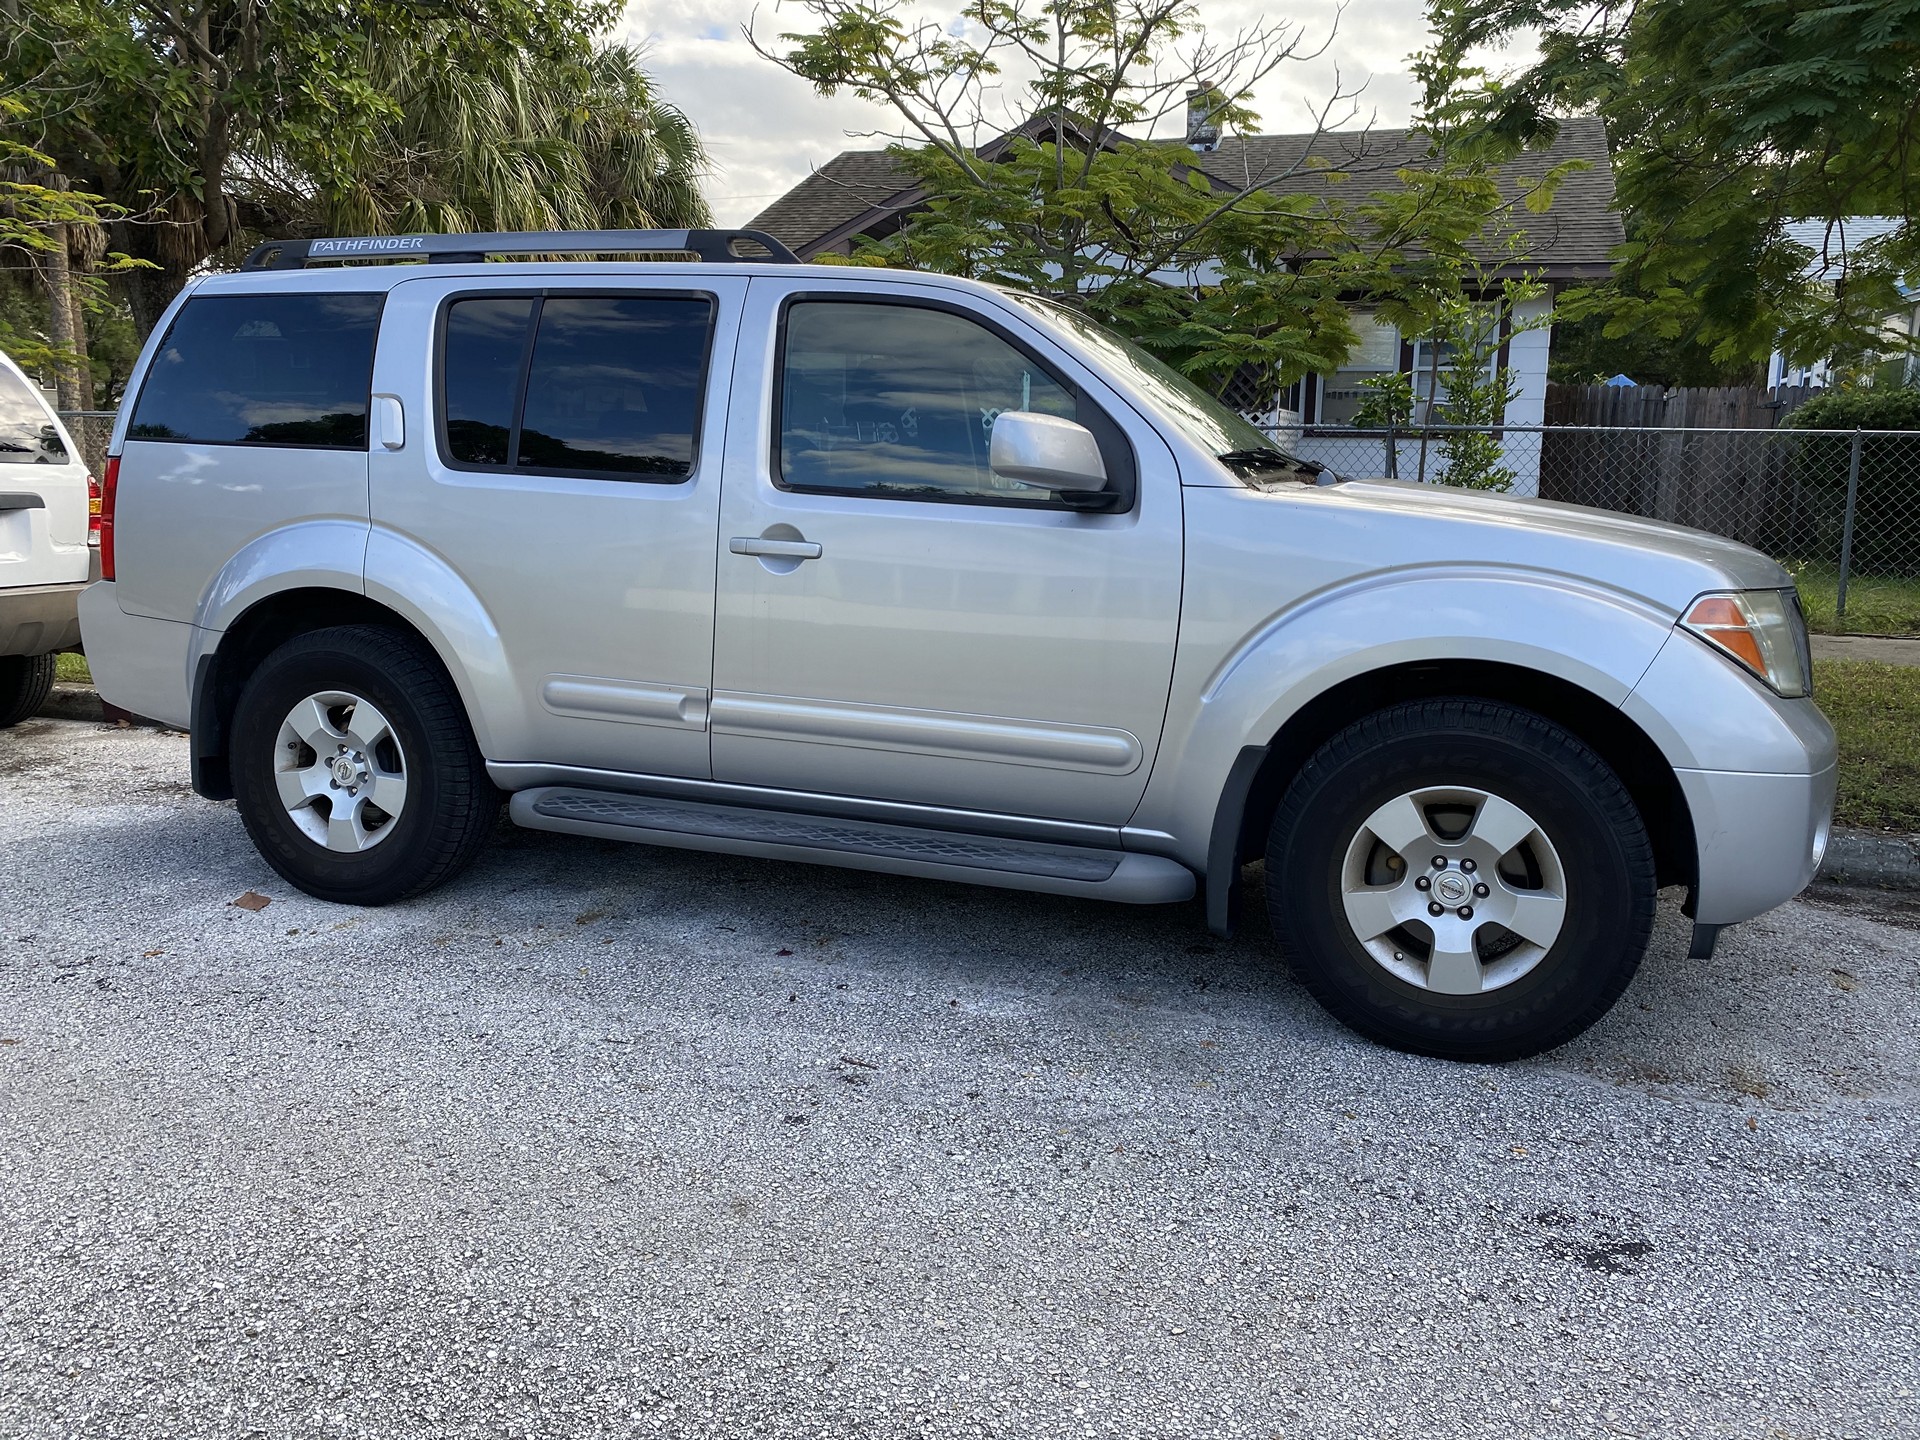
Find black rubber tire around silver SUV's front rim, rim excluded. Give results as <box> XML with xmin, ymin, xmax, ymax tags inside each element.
<box><xmin>1267</xmin><ymin>699</ymin><xmax>1657</xmax><ymax>1062</ymax></box>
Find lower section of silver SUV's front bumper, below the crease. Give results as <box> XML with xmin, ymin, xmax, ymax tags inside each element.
<box><xmin>1674</xmin><ymin>764</ymin><xmax>1839</xmax><ymax>925</ymax></box>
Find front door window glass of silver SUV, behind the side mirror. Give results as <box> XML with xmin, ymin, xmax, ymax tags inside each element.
<box><xmin>780</xmin><ymin>301</ymin><xmax>1077</xmax><ymax>501</ymax></box>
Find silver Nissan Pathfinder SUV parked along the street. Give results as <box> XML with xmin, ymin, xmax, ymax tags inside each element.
<box><xmin>83</xmin><ymin>232</ymin><xmax>1834</xmax><ymax>1060</ymax></box>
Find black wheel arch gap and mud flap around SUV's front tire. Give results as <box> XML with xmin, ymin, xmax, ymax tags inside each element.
<box><xmin>1206</xmin><ymin>659</ymin><xmax>1699</xmax><ymax>933</ymax></box>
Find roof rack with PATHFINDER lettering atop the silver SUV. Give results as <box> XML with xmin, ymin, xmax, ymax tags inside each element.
<box><xmin>240</xmin><ymin>230</ymin><xmax>799</xmax><ymax>271</ymax></box>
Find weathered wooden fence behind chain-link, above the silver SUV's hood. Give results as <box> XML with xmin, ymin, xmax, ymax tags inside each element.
<box><xmin>1540</xmin><ymin>386</ymin><xmax>1826</xmax><ymax>555</ymax></box>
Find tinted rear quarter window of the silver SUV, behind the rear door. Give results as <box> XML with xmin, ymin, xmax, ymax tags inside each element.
<box><xmin>127</xmin><ymin>294</ymin><xmax>382</xmax><ymax>449</ymax></box>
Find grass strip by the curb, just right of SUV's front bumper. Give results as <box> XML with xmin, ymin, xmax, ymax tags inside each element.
<box><xmin>1812</xmin><ymin>660</ymin><xmax>1920</xmax><ymax>831</ymax></box>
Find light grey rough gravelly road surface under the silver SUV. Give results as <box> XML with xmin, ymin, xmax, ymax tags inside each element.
<box><xmin>0</xmin><ymin>720</ymin><xmax>1920</xmax><ymax>1440</ymax></box>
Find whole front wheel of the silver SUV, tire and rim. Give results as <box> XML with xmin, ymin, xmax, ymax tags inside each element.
<box><xmin>1267</xmin><ymin>699</ymin><xmax>1655</xmax><ymax>1060</ymax></box>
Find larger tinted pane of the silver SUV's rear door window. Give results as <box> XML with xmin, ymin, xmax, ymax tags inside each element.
<box><xmin>515</xmin><ymin>296</ymin><xmax>712</xmax><ymax>478</ymax></box>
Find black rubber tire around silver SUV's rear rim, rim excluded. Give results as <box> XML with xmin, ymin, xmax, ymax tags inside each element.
<box><xmin>228</xmin><ymin>626</ymin><xmax>499</xmax><ymax>904</ymax></box>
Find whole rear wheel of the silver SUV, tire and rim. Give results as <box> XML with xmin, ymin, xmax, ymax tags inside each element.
<box><xmin>232</xmin><ymin>626</ymin><xmax>499</xmax><ymax>904</ymax></box>
